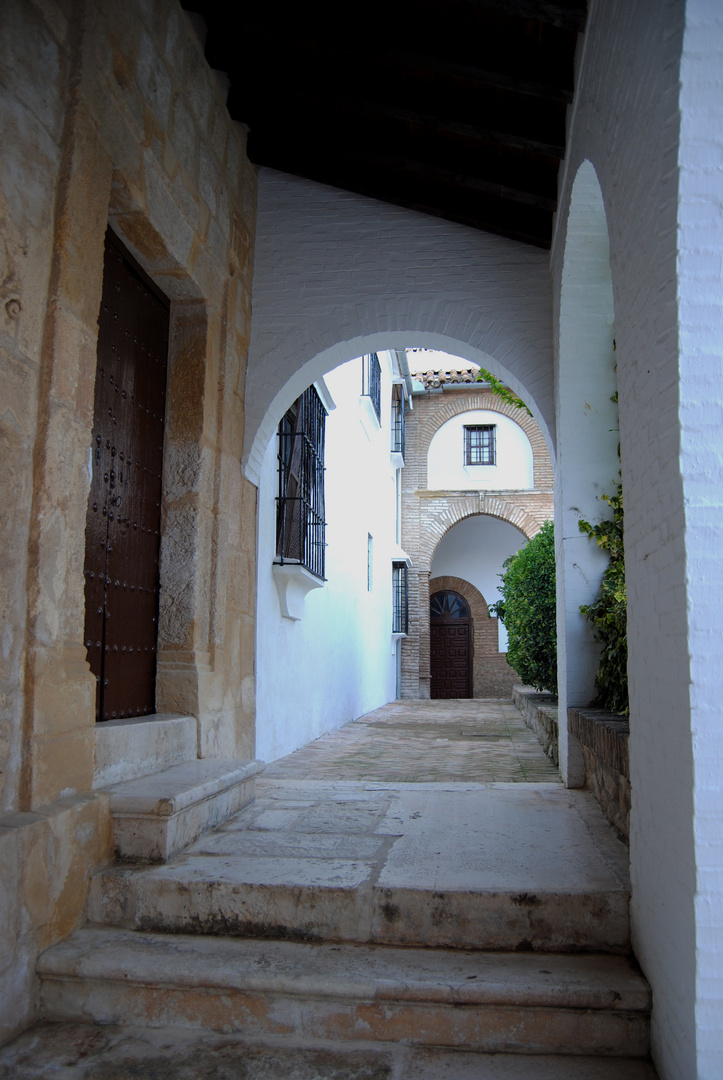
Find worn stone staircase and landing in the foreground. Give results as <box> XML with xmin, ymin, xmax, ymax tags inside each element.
<box><xmin>7</xmin><ymin>780</ymin><xmax>654</xmax><ymax>1080</ymax></box>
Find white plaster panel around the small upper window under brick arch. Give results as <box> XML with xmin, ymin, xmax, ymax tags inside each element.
<box><xmin>427</xmin><ymin>409</ymin><xmax>534</xmax><ymax>491</ymax></box>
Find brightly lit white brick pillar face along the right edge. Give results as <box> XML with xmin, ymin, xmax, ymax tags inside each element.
<box><xmin>678</xmin><ymin>0</ymin><xmax>723</xmax><ymax>1080</ymax></box>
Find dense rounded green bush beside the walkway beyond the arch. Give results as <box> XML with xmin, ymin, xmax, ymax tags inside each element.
<box><xmin>490</xmin><ymin>522</ymin><xmax>558</xmax><ymax>693</ymax></box>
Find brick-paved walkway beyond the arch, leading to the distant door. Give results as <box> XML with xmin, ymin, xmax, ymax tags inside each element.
<box><xmin>264</xmin><ymin>699</ymin><xmax>560</xmax><ymax>783</ymax></box>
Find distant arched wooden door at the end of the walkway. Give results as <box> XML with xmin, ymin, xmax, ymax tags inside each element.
<box><xmin>429</xmin><ymin>592</ymin><xmax>472</xmax><ymax>698</ymax></box>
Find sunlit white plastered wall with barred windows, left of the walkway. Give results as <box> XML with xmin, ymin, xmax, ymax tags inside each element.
<box><xmin>256</xmin><ymin>353</ymin><xmax>399</xmax><ymax>761</ymax></box>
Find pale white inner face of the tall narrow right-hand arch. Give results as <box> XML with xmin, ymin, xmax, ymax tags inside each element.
<box><xmin>554</xmin><ymin>161</ymin><xmax>619</xmax><ymax>786</ymax></box>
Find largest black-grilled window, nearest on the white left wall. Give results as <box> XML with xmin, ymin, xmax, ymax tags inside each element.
<box><xmin>277</xmin><ymin>387</ymin><xmax>326</xmax><ymax>579</ymax></box>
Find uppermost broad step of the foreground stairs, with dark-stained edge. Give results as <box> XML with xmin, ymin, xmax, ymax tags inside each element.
<box><xmin>90</xmin><ymin>859</ymin><xmax>629</xmax><ymax>954</ymax></box>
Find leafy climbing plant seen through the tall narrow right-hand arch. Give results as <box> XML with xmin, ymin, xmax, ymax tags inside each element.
<box><xmin>579</xmin><ymin>482</ymin><xmax>630</xmax><ymax>716</ymax></box>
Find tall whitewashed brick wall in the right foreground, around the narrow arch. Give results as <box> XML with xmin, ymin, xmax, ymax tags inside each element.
<box><xmin>552</xmin><ymin>0</ymin><xmax>723</xmax><ymax>1080</ymax></box>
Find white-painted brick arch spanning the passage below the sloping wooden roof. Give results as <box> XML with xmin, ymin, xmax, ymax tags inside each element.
<box><xmin>243</xmin><ymin>168</ymin><xmax>554</xmax><ymax>483</ymax></box>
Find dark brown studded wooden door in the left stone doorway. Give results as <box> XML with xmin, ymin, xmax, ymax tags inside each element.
<box><xmin>84</xmin><ymin>232</ymin><xmax>169</xmax><ymax>720</ymax></box>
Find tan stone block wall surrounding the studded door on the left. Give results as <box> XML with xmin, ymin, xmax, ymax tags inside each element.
<box><xmin>0</xmin><ymin>0</ymin><xmax>256</xmax><ymax>1036</ymax></box>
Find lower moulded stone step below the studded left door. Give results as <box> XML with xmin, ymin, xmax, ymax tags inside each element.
<box><xmin>106</xmin><ymin>758</ymin><xmax>264</xmax><ymax>863</ymax></box>
